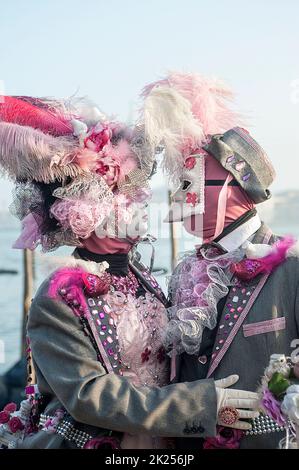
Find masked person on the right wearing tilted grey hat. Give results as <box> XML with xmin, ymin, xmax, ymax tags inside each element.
<box><xmin>142</xmin><ymin>73</ymin><xmax>299</xmax><ymax>449</ymax></box>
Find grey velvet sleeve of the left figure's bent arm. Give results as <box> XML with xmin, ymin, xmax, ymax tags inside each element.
<box><xmin>28</xmin><ymin>280</ymin><xmax>217</xmax><ymax>437</ymax></box>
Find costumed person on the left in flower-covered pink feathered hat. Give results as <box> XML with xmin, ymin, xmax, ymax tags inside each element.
<box><xmin>0</xmin><ymin>93</ymin><xmax>256</xmax><ymax>449</ymax></box>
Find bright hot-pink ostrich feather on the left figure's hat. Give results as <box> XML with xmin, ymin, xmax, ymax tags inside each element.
<box><xmin>0</xmin><ymin>96</ymin><xmax>73</xmax><ymax>136</ymax></box>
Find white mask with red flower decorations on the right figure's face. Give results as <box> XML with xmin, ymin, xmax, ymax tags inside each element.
<box><xmin>164</xmin><ymin>149</ymin><xmax>207</xmax><ymax>222</ymax></box>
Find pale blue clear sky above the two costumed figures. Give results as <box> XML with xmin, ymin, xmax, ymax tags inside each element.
<box><xmin>0</xmin><ymin>0</ymin><xmax>299</xmax><ymax>210</ymax></box>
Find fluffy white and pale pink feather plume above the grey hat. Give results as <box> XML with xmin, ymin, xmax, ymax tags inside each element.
<box><xmin>140</xmin><ymin>72</ymin><xmax>240</xmax><ymax>180</ymax></box>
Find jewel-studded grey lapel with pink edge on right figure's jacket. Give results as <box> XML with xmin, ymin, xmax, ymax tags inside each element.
<box><xmin>207</xmin><ymin>224</ymin><xmax>273</xmax><ymax>377</ymax></box>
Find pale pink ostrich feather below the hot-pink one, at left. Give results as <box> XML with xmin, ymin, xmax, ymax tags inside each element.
<box><xmin>0</xmin><ymin>122</ymin><xmax>83</xmax><ymax>183</ymax></box>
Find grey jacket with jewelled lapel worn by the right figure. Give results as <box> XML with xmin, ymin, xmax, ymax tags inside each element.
<box><xmin>175</xmin><ymin>225</ymin><xmax>299</xmax><ymax>449</ymax></box>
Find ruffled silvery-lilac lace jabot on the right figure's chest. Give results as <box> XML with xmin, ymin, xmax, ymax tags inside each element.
<box><xmin>164</xmin><ymin>248</ymin><xmax>244</xmax><ymax>356</ymax></box>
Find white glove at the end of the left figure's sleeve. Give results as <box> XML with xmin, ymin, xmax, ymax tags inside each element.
<box><xmin>215</xmin><ymin>375</ymin><xmax>259</xmax><ymax>431</ymax></box>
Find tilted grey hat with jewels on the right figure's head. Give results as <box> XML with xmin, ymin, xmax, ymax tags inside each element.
<box><xmin>204</xmin><ymin>127</ymin><xmax>275</xmax><ymax>204</ymax></box>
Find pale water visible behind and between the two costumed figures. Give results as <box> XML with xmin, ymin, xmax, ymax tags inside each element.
<box><xmin>0</xmin><ymin>207</ymin><xmax>299</xmax><ymax>375</ymax></box>
